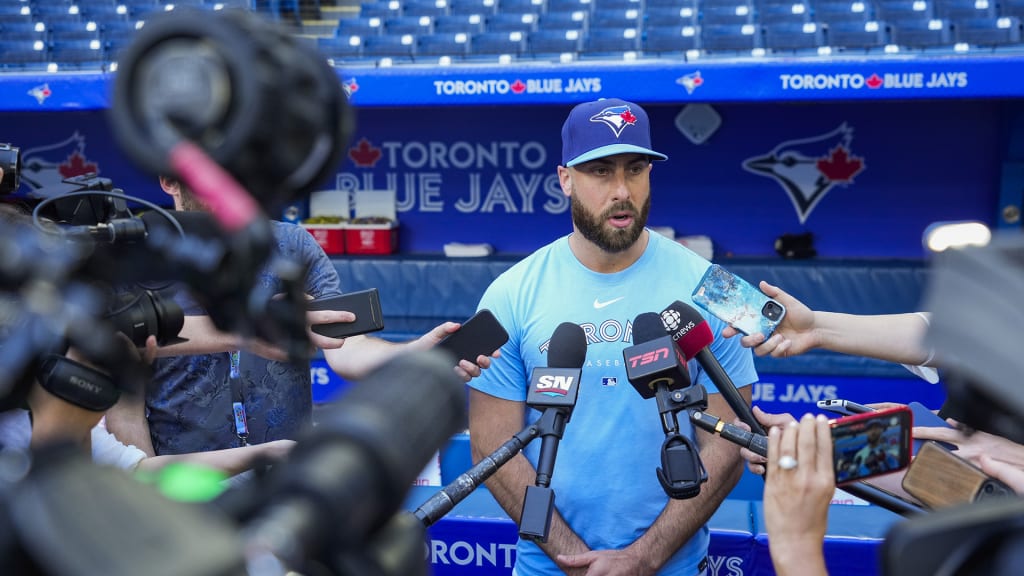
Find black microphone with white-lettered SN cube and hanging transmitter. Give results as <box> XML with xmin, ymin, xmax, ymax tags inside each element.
<box><xmin>519</xmin><ymin>322</ymin><xmax>587</xmax><ymax>542</ymax></box>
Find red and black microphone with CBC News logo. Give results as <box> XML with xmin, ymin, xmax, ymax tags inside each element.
<box><xmin>662</xmin><ymin>300</ymin><xmax>767</xmax><ymax>435</ymax></box>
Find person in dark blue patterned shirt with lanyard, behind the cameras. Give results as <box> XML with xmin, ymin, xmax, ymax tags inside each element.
<box><xmin>108</xmin><ymin>177</ymin><xmax>497</xmax><ymax>455</ymax></box>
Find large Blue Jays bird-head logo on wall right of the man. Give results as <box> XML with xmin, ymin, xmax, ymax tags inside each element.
<box><xmin>742</xmin><ymin>123</ymin><xmax>866</xmax><ymax>223</ymax></box>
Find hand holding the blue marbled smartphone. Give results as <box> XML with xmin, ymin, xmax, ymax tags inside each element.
<box><xmin>722</xmin><ymin>280</ymin><xmax>819</xmax><ymax>358</ymax></box>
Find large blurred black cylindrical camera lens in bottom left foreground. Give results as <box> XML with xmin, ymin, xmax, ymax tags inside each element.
<box><xmin>242</xmin><ymin>351</ymin><xmax>466</xmax><ymax>574</ymax></box>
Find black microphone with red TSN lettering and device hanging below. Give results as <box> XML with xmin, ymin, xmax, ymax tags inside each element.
<box><xmin>623</xmin><ymin>312</ymin><xmax>708</xmax><ymax>499</ymax></box>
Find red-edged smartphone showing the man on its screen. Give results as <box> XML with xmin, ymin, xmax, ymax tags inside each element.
<box><xmin>831</xmin><ymin>406</ymin><xmax>913</xmax><ymax>485</ymax></box>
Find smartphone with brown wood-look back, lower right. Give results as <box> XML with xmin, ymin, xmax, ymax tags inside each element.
<box><xmin>902</xmin><ymin>441</ymin><xmax>1014</xmax><ymax>508</ymax></box>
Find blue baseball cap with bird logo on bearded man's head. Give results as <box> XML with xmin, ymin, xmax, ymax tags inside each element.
<box><xmin>562</xmin><ymin>98</ymin><xmax>669</xmax><ymax>167</ymax></box>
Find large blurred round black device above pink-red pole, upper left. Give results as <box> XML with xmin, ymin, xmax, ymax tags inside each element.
<box><xmin>109</xmin><ymin>9</ymin><xmax>353</xmax><ymax>214</ymax></box>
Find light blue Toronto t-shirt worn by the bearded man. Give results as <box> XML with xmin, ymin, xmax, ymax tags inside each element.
<box><xmin>469</xmin><ymin>232</ymin><xmax>757</xmax><ymax>576</ymax></box>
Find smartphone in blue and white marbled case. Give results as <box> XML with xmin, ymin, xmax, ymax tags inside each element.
<box><xmin>691</xmin><ymin>264</ymin><xmax>785</xmax><ymax>338</ymax></box>
